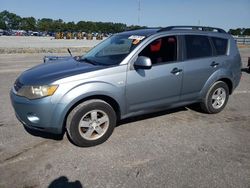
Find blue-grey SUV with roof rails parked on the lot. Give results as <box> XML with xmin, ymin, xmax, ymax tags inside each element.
<box><xmin>10</xmin><ymin>26</ymin><xmax>241</xmax><ymax>146</ymax></box>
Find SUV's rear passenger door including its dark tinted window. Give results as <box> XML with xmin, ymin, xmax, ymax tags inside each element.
<box><xmin>181</xmin><ymin>35</ymin><xmax>220</xmax><ymax>101</ymax></box>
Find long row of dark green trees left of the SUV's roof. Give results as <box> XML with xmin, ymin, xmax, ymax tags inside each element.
<box><xmin>0</xmin><ymin>10</ymin><xmax>145</xmax><ymax>33</ymax></box>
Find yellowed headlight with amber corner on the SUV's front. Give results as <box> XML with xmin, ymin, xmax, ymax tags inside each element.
<box><xmin>16</xmin><ymin>85</ymin><xmax>58</xmax><ymax>99</ymax></box>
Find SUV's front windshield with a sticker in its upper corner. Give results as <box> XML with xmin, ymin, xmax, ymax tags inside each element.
<box><xmin>80</xmin><ymin>35</ymin><xmax>145</xmax><ymax>65</ymax></box>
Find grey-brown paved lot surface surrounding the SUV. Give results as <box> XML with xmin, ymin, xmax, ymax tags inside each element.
<box><xmin>0</xmin><ymin>48</ymin><xmax>250</xmax><ymax>188</ymax></box>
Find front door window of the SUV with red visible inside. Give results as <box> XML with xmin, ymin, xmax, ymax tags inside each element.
<box><xmin>139</xmin><ymin>36</ymin><xmax>177</xmax><ymax>64</ymax></box>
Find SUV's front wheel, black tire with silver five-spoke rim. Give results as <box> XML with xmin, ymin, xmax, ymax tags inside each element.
<box><xmin>66</xmin><ymin>99</ymin><xmax>117</xmax><ymax>147</ymax></box>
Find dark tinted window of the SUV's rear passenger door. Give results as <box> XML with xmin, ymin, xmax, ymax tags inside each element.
<box><xmin>185</xmin><ymin>35</ymin><xmax>212</xmax><ymax>59</ymax></box>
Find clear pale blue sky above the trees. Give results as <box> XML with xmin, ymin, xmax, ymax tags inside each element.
<box><xmin>0</xmin><ymin>0</ymin><xmax>250</xmax><ymax>30</ymax></box>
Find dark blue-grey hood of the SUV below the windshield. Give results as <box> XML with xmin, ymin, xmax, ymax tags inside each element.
<box><xmin>18</xmin><ymin>58</ymin><xmax>106</xmax><ymax>85</ymax></box>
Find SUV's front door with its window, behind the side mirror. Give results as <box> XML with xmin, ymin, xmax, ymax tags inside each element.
<box><xmin>126</xmin><ymin>36</ymin><xmax>183</xmax><ymax>113</ymax></box>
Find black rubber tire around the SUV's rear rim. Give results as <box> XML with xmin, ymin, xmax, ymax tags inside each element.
<box><xmin>200</xmin><ymin>81</ymin><xmax>229</xmax><ymax>114</ymax></box>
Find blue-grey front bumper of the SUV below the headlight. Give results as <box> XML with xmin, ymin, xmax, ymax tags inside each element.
<box><xmin>10</xmin><ymin>90</ymin><xmax>62</xmax><ymax>134</ymax></box>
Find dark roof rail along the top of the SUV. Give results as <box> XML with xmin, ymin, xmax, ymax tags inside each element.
<box><xmin>157</xmin><ymin>25</ymin><xmax>226</xmax><ymax>33</ymax></box>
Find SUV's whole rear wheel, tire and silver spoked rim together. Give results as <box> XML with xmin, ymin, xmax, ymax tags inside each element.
<box><xmin>201</xmin><ymin>81</ymin><xmax>229</xmax><ymax>114</ymax></box>
